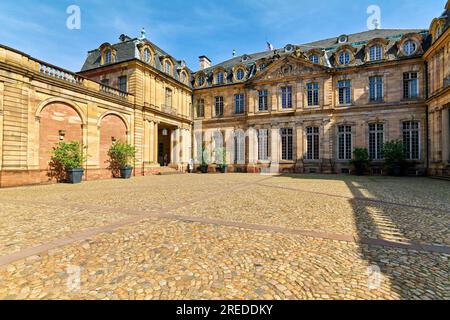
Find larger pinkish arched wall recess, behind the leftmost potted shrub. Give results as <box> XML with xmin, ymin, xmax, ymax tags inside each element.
<box><xmin>39</xmin><ymin>102</ymin><xmax>83</xmax><ymax>181</ymax></box>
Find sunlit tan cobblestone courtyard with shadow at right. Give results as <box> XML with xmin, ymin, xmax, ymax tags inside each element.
<box><xmin>0</xmin><ymin>174</ymin><xmax>450</xmax><ymax>299</ymax></box>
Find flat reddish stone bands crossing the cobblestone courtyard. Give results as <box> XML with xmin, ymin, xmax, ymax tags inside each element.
<box><xmin>0</xmin><ymin>178</ymin><xmax>450</xmax><ymax>267</ymax></box>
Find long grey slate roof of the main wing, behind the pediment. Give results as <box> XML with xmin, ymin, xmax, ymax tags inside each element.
<box><xmin>193</xmin><ymin>29</ymin><xmax>428</xmax><ymax>86</ymax></box>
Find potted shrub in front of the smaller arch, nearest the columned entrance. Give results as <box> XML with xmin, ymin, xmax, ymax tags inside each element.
<box><xmin>108</xmin><ymin>141</ymin><xmax>136</xmax><ymax>179</ymax></box>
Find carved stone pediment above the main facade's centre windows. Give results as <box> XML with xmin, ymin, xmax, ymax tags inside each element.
<box><xmin>252</xmin><ymin>56</ymin><xmax>329</xmax><ymax>81</ymax></box>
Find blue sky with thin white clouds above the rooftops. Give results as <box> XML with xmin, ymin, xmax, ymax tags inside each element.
<box><xmin>0</xmin><ymin>0</ymin><xmax>445</xmax><ymax>71</ymax></box>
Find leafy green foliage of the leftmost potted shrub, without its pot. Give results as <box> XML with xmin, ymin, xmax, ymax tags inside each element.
<box><xmin>51</xmin><ymin>141</ymin><xmax>85</xmax><ymax>171</ymax></box>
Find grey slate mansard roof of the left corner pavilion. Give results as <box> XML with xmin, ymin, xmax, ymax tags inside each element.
<box><xmin>81</xmin><ymin>35</ymin><xmax>191</xmax><ymax>84</ymax></box>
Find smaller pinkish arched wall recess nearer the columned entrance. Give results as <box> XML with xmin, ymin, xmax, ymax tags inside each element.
<box><xmin>99</xmin><ymin>114</ymin><xmax>128</xmax><ymax>178</ymax></box>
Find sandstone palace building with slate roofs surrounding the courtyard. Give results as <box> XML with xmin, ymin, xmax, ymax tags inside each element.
<box><xmin>0</xmin><ymin>1</ymin><xmax>450</xmax><ymax>187</ymax></box>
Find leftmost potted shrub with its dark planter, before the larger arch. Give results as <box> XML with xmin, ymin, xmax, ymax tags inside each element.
<box><xmin>51</xmin><ymin>141</ymin><xmax>85</xmax><ymax>184</ymax></box>
